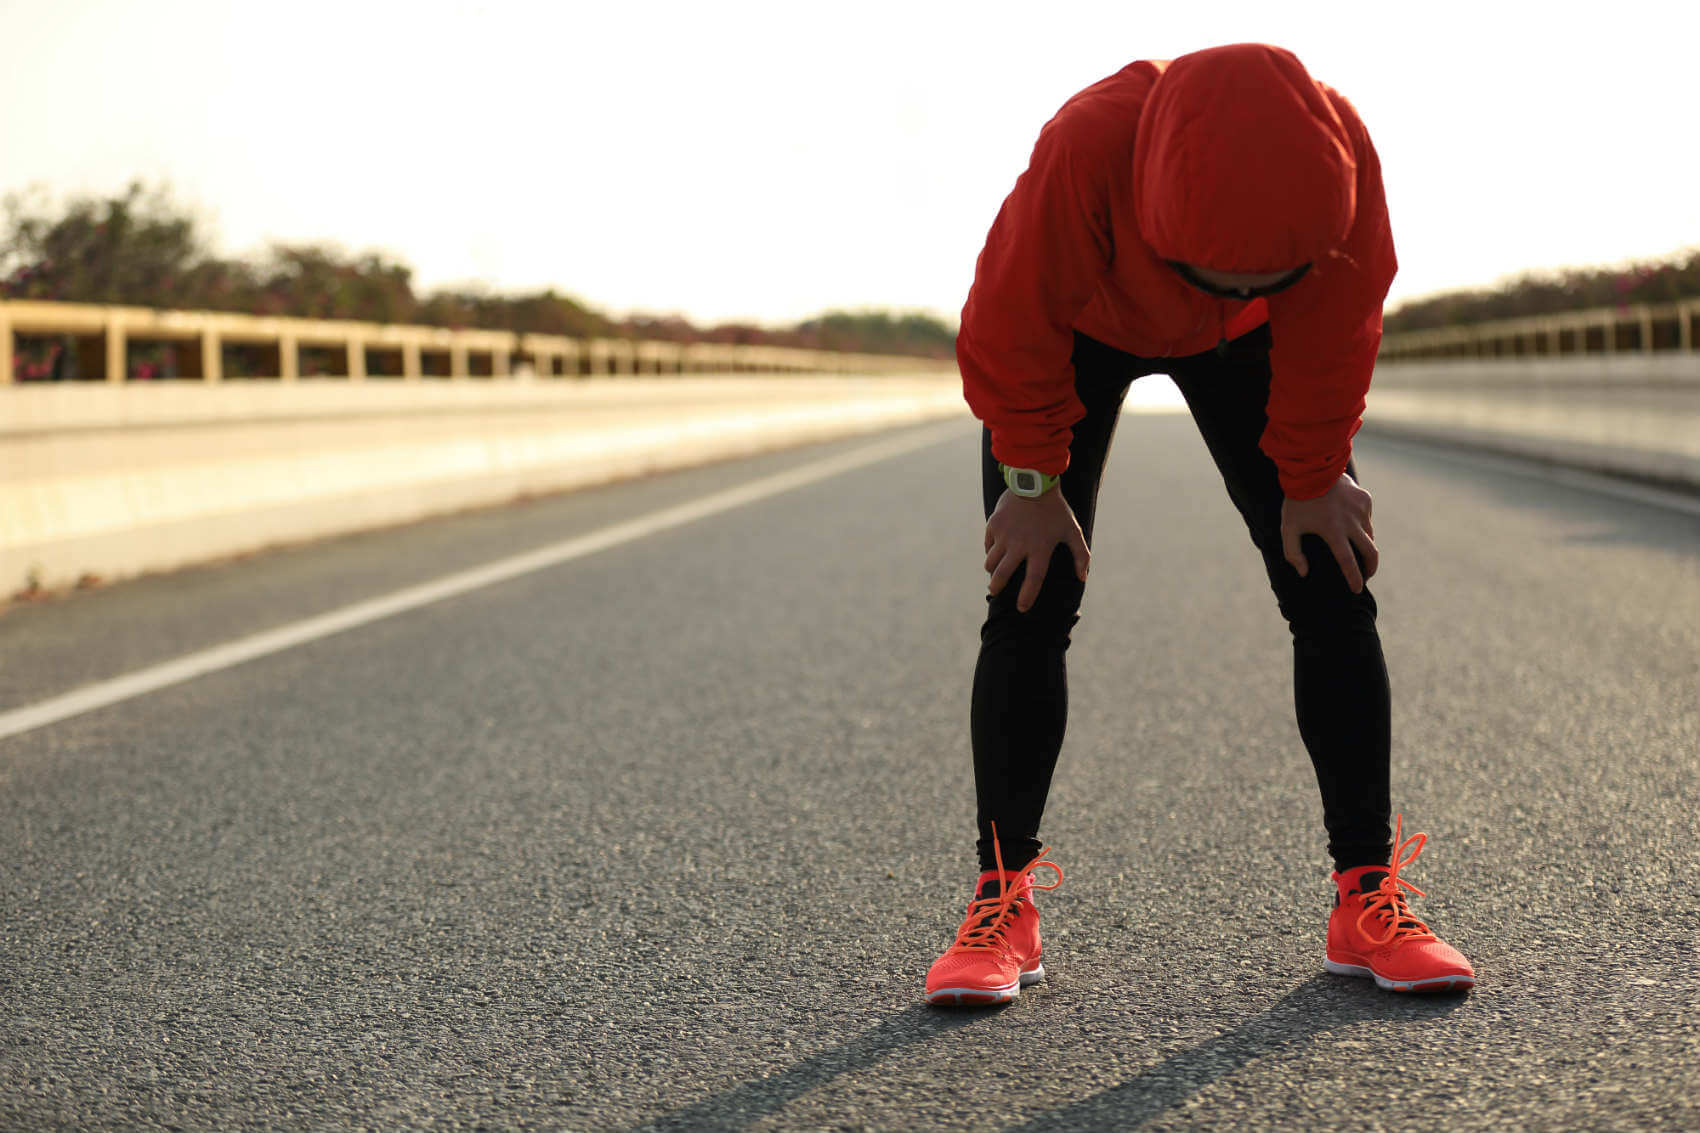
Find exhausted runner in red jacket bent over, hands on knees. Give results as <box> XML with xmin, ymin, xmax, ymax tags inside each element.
<box><xmin>927</xmin><ymin>44</ymin><xmax>1476</xmax><ymax>1005</ymax></box>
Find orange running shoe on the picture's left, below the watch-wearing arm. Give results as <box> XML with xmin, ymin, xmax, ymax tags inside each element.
<box><xmin>927</xmin><ymin>828</ymin><xmax>1063</xmax><ymax>1007</ymax></box>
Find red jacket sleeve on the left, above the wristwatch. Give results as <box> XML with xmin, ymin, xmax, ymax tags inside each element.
<box><xmin>957</xmin><ymin>114</ymin><xmax>1114</xmax><ymax>475</ymax></box>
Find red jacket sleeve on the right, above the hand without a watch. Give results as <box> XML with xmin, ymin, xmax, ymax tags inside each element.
<box><xmin>1260</xmin><ymin>92</ymin><xmax>1399</xmax><ymax>500</ymax></box>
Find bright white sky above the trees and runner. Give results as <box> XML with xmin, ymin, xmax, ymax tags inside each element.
<box><xmin>0</xmin><ymin>0</ymin><xmax>1700</xmax><ymax>323</ymax></box>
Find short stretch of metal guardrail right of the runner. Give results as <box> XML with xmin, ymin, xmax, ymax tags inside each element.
<box><xmin>1380</xmin><ymin>299</ymin><xmax>1700</xmax><ymax>362</ymax></box>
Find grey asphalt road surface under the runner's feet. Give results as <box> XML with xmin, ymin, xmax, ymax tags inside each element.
<box><xmin>0</xmin><ymin>409</ymin><xmax>1700</xmax><ymax>1130</ymax></box>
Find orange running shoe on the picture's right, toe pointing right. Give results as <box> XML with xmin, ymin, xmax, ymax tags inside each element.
<box><xmin>1326</xmin><ymin>815</ymin><xmax>1476</xmax><ymax>992</ymax></box>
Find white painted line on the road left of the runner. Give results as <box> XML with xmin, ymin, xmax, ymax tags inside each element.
<box><xmin>0</xmin><ymin>420</ymin><xmax>967</xmax><ymax>740</ymax></box>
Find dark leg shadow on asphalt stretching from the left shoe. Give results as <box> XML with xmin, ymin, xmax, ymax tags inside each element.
<box><xmin>632</xmin><ymin>1004</ymin><xmax>1003</xmax><ymax>1133</ymax></box>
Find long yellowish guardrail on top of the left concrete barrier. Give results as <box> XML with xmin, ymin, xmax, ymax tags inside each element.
<box><xmin>0</xmin><ymin>299</ymin><xmax>950</xmax><ymax>384</ymax></box>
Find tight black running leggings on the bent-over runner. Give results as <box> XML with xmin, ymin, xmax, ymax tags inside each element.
<box><xmin>972</xmin><ymin>325</ymin><xmax>1392</xmax><ymax>869</ymax></box>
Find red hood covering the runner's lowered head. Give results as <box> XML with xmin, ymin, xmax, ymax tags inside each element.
<box><xmin>1134</xmin><ymin>43</ymin><xmax>1357</xmax><ymax>272</ymax></box>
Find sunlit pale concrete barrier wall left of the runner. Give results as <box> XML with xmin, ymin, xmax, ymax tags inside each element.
<box><xmin>0</xmin><ymin>371</ymin><xmax>967</xmax><ymax>597</ymax></box>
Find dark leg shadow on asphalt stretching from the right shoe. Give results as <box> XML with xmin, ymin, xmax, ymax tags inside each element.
<box><xmin>1015</xmin><ymin>973</ymin><xmax>1469</xmax><ymax>1133</ymax></box>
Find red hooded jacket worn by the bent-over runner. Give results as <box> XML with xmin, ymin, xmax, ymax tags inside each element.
<box><xmin>957</xmin><ymin>44</ymin><xmax>1397</xmax><ymax>498</ymax></box>
